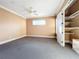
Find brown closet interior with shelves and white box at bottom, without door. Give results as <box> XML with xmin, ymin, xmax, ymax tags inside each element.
<box><xmin>65</xmin><ymin>0</ymin><xmax>79</xmax><ymax>54</ymax></box>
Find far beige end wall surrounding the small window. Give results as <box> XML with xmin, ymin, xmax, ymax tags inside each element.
<box><xmin>27</xmin><ymin>17</ymin><xmax>55</xmax><ymax>36</ymax></box>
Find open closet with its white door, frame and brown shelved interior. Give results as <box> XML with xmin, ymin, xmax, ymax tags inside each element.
<box><xmin>56</xmin><ymin>0</ymin><xmax>79</xmax><ymax>47</ymax></box>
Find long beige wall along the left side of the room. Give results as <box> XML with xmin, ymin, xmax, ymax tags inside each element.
<box><xmin>0</xmin><ymin>8</ymin><xmax>26</xmax><ymax>41</ymax></box>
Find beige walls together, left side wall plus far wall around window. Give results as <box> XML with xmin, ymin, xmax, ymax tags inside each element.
<box><xmin>0</xmin><ymin>8</ymin><xmax>55</xmax><ymax>42</ymax></box>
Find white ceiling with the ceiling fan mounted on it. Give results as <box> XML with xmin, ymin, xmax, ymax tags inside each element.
<box><xmin>0</xmin><ymin>0</ymin><xmax>65</xmax><ymax>18</ymax></box>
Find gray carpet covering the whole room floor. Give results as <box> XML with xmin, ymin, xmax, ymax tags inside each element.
<box><xmin>0</xmin><ymin>38</ymin><xmax>79</xmax><ymax>59</ymax></box>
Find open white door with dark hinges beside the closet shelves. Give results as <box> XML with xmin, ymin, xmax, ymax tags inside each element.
<box><xmin>56</xmin><ymin>11</ymin><xmax>65</xmax><ymax>47</ymax></box>
